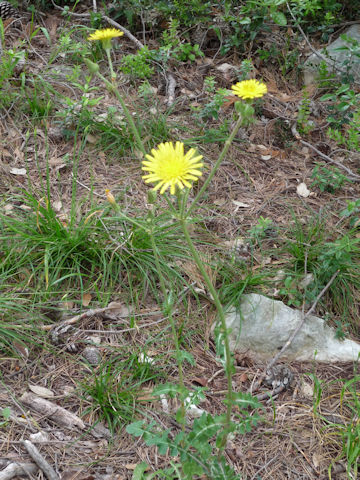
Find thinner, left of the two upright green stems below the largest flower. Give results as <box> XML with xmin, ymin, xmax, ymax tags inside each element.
<box><xmin>150</xmin><ymin>221</ymin><xmax>186</xmax><ymax>424</ymax></box>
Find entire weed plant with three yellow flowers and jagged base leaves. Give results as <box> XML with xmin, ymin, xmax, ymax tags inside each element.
<box><xmin>84</xmin><ymin>30</ymin><xmax>267</xmax><ymax>480</ymax></box>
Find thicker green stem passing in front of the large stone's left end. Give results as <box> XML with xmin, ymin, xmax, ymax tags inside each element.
<box><xmin>180</xmin><ymin>218</ymin><xmax>233</xmax><ymax>438</ymax></box>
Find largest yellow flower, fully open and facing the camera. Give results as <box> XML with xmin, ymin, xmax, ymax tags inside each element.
<box><xmin>142</xmin><ymin>142</ymin><xmax>203</xmax><ymax>195</ymax></box>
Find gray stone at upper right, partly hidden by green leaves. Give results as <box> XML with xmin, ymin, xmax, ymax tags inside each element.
<box><xmin>304</xmin><ymin>24</ymin><xmax>360</xmax><ymax>85</ymax></box>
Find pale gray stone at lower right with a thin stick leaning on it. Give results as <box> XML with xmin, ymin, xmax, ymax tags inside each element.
<box><xmin>226</xmin><ymin>293</ymin><xmax>360</xmax><ymax>362</ymax></box>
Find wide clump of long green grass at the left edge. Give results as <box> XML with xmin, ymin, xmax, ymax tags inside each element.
<box><xmin>0</xmin><ymin>188</ymin><xmax>193</xmax><ymax>308</ymax></box>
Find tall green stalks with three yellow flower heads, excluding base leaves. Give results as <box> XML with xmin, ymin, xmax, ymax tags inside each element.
<box><xmin>84</xmin><ymin>39</ymin><xmax>267</xmax><ymax>451</ymax></box>
